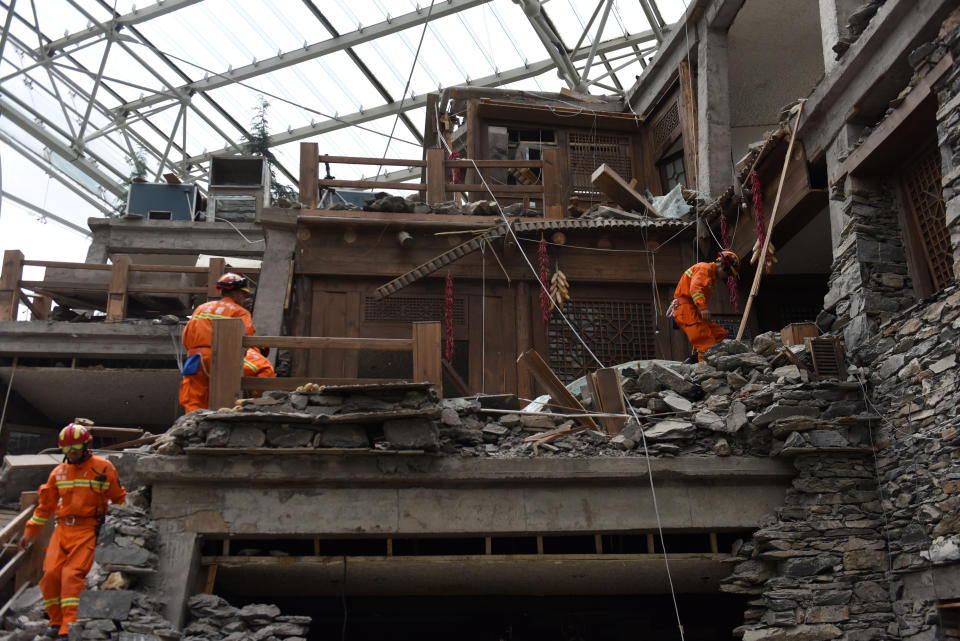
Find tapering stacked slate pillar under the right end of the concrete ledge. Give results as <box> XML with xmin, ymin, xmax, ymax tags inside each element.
<box><xmin>721</xmin><ymin>448</ymin><xmax>900</xmax><ymax>641</ymax></box>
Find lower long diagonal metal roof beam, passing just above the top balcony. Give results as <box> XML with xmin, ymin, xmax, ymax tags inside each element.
<box><xmin>181</xmin><ymin>31</ymin><xmax>654</xmax><ymax>163</ymax></box>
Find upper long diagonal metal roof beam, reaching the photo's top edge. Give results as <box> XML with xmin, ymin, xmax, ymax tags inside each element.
<box><xmin>118</xmin><ymin>0</ymin><xmax>491</xmax><ymax>111</ymax></box>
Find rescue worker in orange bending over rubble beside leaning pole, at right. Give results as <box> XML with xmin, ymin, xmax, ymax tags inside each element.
<box><xmin>673</xmin><ymin>250</ymin><xmax>740</xmax><ymax>360</ymax></box>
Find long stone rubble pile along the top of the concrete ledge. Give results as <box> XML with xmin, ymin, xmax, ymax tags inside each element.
<box><xmin>153</xmin><ymin>332</ymin><xmax>871</xmax><ymax>458</ymax></box>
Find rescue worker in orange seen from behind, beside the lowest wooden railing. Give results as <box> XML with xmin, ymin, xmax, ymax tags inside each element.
<box><xmin>180</xmin><ymin>272</ymin><xmax>256</xmax><ymax>413</ymax></box>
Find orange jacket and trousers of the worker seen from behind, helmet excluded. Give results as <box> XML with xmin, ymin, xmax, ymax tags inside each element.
<box><xmin>180</xmin><ymin>297</ymin><xmax>256</xmax><ymax>412</ymax></box>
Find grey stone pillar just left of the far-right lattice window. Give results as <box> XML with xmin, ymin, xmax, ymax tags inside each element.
<box><xmin>817</xmin><ymin>178</ymin><xmax>914</xmax><ymax>349</ymax></box>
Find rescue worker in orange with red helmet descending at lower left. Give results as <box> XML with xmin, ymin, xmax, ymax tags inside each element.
<box><xmin>18</xmin><ymin>423</ymin><xmax>127</xmax><ymax>638</ymax></box>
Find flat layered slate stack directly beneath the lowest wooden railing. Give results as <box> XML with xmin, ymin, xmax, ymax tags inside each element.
<box><xmin>153</xmin><ymin>383</ymin><xmax>440</xmax><ymax>455</ymax></box>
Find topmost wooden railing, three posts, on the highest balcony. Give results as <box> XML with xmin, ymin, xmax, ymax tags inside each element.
<box><xmin>300</xmin><ymin>142</ymin><xmax>563</xmax><ymax>218</ymax></box>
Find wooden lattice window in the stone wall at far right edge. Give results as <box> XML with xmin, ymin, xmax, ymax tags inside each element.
<box><xmin>901</xmin><ymin>142</ymin><xmax>953</xmax><ymax>291</ymax></box>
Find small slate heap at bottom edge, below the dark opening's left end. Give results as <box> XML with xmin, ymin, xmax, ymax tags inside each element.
<box><xmin>182</xmin><ymin>594</ymin><xmax>312</xmax><ymax>641</ymax></box>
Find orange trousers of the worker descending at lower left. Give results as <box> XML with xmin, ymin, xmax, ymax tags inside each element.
<box><xmin>40</xmin><ymin>519</ymin><xmax>97</xmax><ymax>635</ymax></box>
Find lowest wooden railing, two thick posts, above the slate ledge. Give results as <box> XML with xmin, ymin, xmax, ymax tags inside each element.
<box><xmin>209</xmin><ymin>318</ymin><xmax>443</xmax><ymax>409</ymax></box>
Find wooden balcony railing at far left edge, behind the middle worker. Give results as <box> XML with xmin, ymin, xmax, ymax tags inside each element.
<box><xmin>0</xmin><ymin>249</ymin><xmax>260</xmax><ymax>323</ymax></box>
